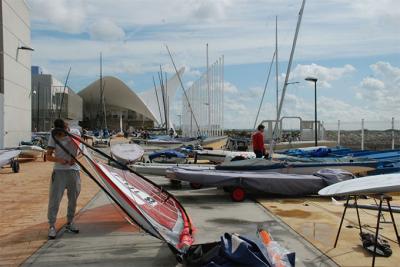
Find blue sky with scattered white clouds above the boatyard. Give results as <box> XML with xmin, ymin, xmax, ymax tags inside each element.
<box><xmin>27</xmin><ymin>0</ymin><xmax>400</xmax><ymax>129</ymax></box>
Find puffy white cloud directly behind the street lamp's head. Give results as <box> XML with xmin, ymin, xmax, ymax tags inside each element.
<box><xmin>291</xmin><ymin>63</ymin><xmax>356</xmax><ymax>87</ymax></box>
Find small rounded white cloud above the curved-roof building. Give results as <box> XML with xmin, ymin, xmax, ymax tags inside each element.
<box><xmin>89</xmin><ymin>19</ymin><xmax>125</xmax><ymax>41</ymax></box>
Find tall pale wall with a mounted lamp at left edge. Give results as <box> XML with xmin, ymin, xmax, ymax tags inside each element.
<box><xmin>0</xmin><ymin>0</ymin><xmax>32</xmax><ymax>148</ymax></box>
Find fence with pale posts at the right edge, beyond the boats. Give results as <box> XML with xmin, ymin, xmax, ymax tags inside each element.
<box><xmin>323</xmin><ymin>118</ymin><xmax>400</xmax><ymax>150</ymax></box>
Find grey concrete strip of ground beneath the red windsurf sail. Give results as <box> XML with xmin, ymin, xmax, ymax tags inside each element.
<box><xmin>23</xmin><ymin>177</ymin><xmax>337</xmax><ymax>267</ymax></box>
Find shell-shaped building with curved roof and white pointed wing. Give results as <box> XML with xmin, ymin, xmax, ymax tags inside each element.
<box><xmin>78</xmin><ymin>68</ymin><xmax>184</xmax><ymax>131</ymax></box>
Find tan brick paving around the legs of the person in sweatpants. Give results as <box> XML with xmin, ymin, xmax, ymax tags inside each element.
<box><xmin>0</xmin><ymin>159</ymin><xmax>99</xmax><ymax>266</ymax></box>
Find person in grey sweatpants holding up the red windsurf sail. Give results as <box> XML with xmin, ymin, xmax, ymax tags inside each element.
<box><xmin>46</xmin><ymin>119</ymin><xmax>81</xmax><ymax>239</ymax></box>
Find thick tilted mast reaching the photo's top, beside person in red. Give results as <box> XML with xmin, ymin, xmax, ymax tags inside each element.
<box><xmin>270</xmin><ymin>0</ymin><xmax>306</xmax><ymax>147</ymax></box>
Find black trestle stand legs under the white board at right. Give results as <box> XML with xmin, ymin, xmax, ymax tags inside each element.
<box><xmin>333</xmin><ymin>194</ymin><xmax>400</xmax><ymax>267</ymax></box>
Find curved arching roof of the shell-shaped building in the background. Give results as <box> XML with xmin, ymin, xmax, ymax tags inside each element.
<box><xmin>78</xmin><ymin>76</ymin><xmax>158</xmax><ymax>122</ymax></box>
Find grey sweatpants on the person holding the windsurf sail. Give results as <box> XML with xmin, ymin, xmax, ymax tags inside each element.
<box><xmin>47</xmin><ymin>170</ymin><xmax>81</xmax><ymax>225</ymax></box>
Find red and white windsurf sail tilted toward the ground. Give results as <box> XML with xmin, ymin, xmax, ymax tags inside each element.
<box><xmin>52</xmin><ymin>129</ymin><xmax>194</xmax><ymax>255</ymax></box>
